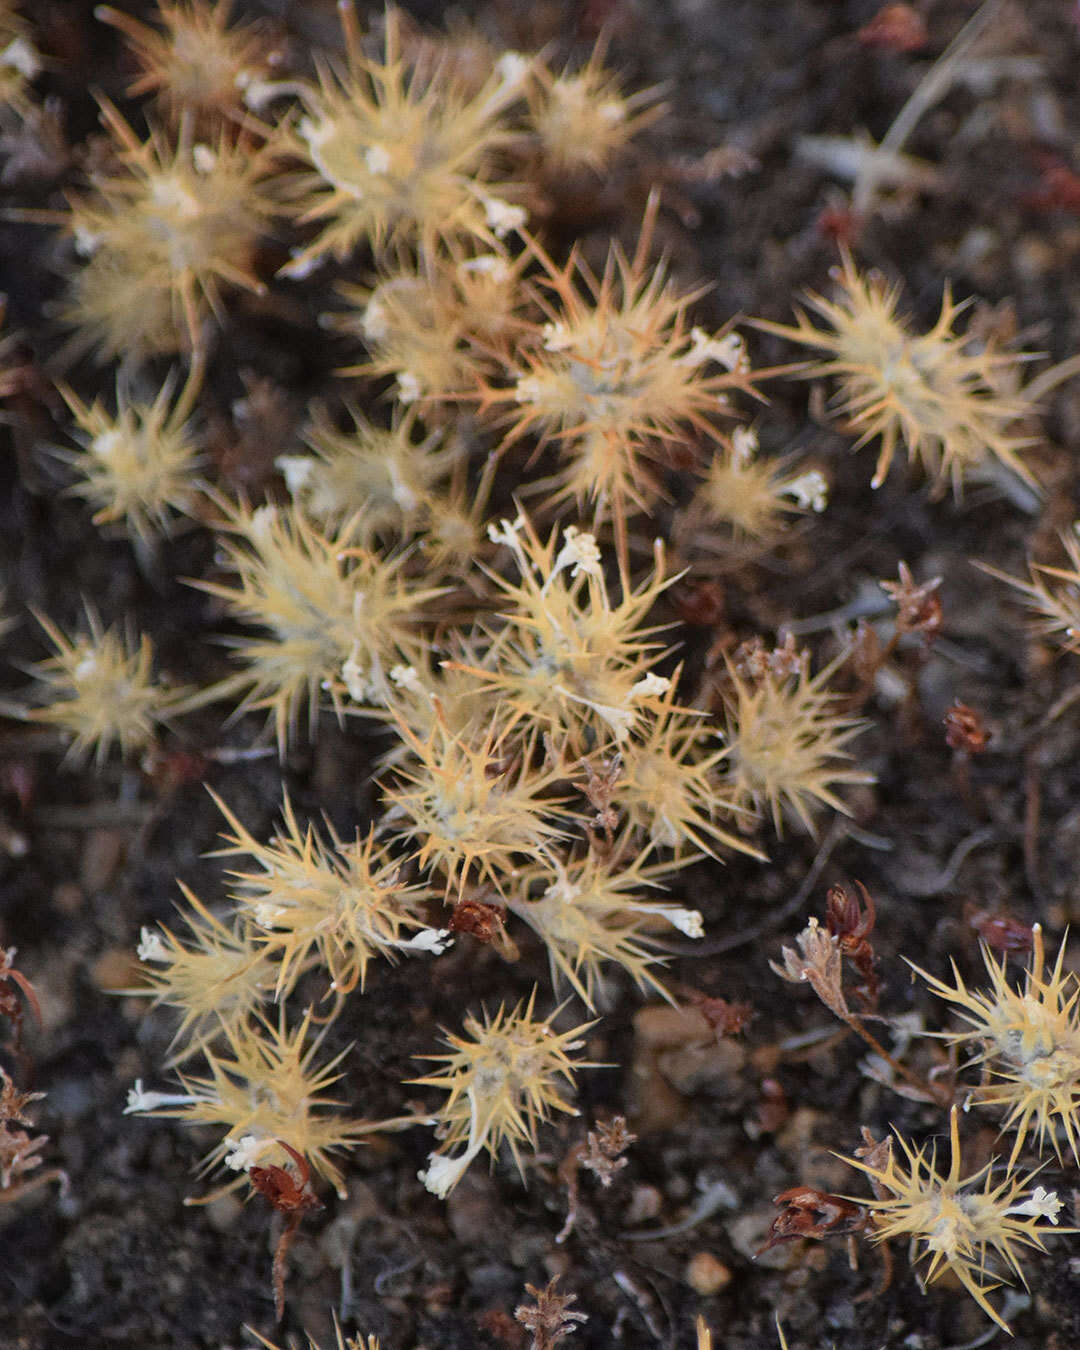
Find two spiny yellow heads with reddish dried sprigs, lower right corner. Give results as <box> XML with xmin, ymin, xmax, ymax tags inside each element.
<box><xmin>768</xmin><ymin>887</ymin><xmax>1080</xmax><ymax>1331</ymax></box>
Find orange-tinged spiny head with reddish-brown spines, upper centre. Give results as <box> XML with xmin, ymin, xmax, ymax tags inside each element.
<box><xmin>482</xmin><ymin>194</ymin><xmax>753</xmax><ymax>558</ymax></box>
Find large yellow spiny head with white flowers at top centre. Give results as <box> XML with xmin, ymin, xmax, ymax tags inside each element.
<box><xmin>286</xmin><ymin>0</ymin><xmax>525</xmax><ymax>274</ymax></box>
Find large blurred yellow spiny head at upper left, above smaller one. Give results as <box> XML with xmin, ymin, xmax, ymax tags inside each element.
<box><xmin>65</xmin><ymin>101</ymin><xmax>278</xmax><ymax>360</ymax></box>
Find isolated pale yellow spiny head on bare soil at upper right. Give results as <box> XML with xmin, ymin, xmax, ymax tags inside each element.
<box><xmin>757</xmin><ymin>252</ymin><xmax>1034</xmax><ymax>495</ymax></box>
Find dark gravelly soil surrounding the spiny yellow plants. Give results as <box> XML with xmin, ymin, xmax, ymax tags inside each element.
<box><xmin>0</xmin><ymin>0</ymin><xmax>1080</xmax><ymax>1350</ymax></box>
